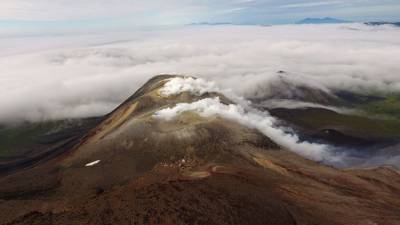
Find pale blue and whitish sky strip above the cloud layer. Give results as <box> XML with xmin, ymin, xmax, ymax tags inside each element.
<box><xmin>0</xmin><ymin>0</ymin><xmax>400</xmax><ymax>29</ymax></box>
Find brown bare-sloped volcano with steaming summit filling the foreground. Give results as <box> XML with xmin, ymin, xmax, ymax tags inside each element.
<box><xmin>0</xmin><ymin>75</ymin><xmax>400</xmax><ymax>225</ymax></box>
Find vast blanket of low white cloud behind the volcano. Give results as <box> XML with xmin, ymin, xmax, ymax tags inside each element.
<box><xmin>0</xmin><ymin>24</ymin><xmax>400</xmax><ymax>122</ymax></box>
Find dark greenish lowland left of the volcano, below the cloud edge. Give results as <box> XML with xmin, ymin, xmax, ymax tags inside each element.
<box><xmin>0</xmin><ymin>118</ymin><xmax>102</xmax><ymax>175</ymax></box>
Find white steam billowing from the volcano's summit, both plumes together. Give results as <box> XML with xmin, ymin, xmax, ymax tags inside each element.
<box><xmin>153</xmin><ymin>77</ymin><xmax>342</xmax><ymax>163</ymax></box>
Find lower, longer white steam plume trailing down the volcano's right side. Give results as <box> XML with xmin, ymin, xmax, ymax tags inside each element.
<box><xmin>154</xmin><ymin>98</ymin><xmax>341</xmax><ymax>163</ymax></box>
